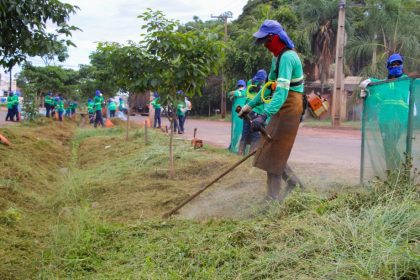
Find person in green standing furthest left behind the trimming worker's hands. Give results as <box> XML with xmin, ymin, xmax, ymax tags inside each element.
<box><xmin>228</xmin><ymin>80</ymin><xmax>246</xmax><ymax>154</ymax></box>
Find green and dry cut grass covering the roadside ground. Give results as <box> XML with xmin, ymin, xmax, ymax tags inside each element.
<box><xmin>0</xmin><ymin>119</ymin><xmax>420</xmax><ymax>279</ymax></box>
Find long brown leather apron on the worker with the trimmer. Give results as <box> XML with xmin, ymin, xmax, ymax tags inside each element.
<box><xmin>253</xmin><ymin>91</ymin><xmax>303</xmax><ymax>175</ymax></box>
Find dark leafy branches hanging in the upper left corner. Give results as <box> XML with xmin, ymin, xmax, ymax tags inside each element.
<box><xmin>0</xmin><ymin>0</ymin><xmax>78</xmax><ymax>69</ymax></box>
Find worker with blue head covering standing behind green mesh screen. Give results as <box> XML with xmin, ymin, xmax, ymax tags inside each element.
<box><xmin>360</xmin><ymin>53</ymin><xmax>408</xmax><ymax>171</ymax></box>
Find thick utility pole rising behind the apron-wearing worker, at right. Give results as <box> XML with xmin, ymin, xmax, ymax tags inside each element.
<box><xmin>331</xmin><ymin>0</ymin><xmax>346</xmax><ymax>128</ymax></box>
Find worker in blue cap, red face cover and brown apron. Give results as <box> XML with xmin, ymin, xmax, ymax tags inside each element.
<box><xmin>239</xmin><ymin>20</ymin><xmax>304</xmax><ymax>201</ymax></box>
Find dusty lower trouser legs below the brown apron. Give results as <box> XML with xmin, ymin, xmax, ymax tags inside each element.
<box><xmin>267</xmin><ymin>164</ymin><xmax>303</xmax><ymax>201</ymax></box>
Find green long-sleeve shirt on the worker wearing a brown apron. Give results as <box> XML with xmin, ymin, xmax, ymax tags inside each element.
<box><xmin>248</xmin><ymin>50</ymin><xmax>304</xmax><ymax>117</ymax></box>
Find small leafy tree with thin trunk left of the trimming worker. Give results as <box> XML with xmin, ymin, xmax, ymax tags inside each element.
<box><xmin>138</xmin><ymin>9</ymin><xmax>223</xmax><ymax>176</ymax></box>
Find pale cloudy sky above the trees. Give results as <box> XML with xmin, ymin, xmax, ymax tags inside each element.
<box><xmin>26</xmin><ymin>0</ymin><xmax>248</xmax><ymax>69</ymax></box>
